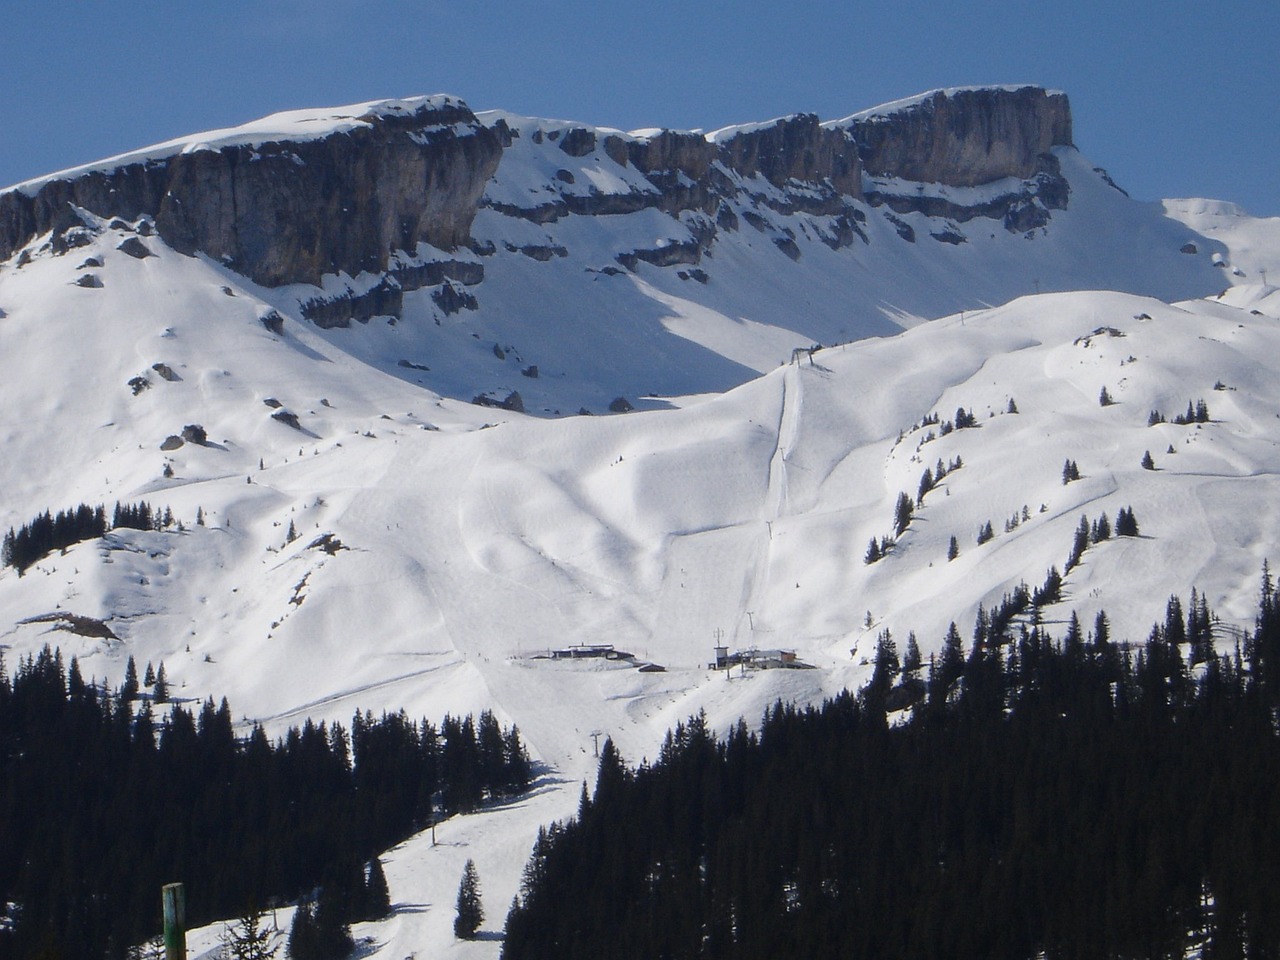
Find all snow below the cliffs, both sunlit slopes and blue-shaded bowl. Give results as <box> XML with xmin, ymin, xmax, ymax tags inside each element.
<box><xmin>0</xmin><ymin>96</ymin><xmax>1280</xmax><ymax>960</ymax></box>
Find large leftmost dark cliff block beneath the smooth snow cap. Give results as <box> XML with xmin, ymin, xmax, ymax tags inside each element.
<box><xmin>0</xmin><ymin>101</ymin><xmax>502</xmax><ymax>287</ymax></box>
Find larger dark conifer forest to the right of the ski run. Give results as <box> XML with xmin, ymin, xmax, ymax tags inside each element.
<box><xmin>502</xmin><ymin>571</ymin><xmax>1280</xmax><ymax>960</ymax></box>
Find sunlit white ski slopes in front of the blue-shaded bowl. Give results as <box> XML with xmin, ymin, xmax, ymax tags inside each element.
<box><xmin>0</xmin><ymin>213</ymin><xmax>1280</xmax><ymax>956</ymax></box>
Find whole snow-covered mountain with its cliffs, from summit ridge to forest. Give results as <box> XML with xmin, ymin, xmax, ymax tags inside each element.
<box><xmin>0</xmin><ymin>87</ymin><xmax>1280</xmax><ymax>957</ymax></box>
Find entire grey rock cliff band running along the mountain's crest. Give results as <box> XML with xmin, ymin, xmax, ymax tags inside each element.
<box><xmin>0</xmin><ymin>87</ymin><xmax>1071</xmax><ymax>326</ymax></box>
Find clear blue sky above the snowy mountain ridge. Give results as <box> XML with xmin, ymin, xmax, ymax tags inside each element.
<box><xmin>0</xmin><ymin>0</ymin><xmax>1280</xmax><ymax>216</ymax></box>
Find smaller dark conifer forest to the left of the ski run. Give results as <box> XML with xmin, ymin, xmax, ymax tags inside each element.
<box><xmin>0</xmin><ymin>646</ymin><xmax>531</xmax><ymax>960</ymax></box>
